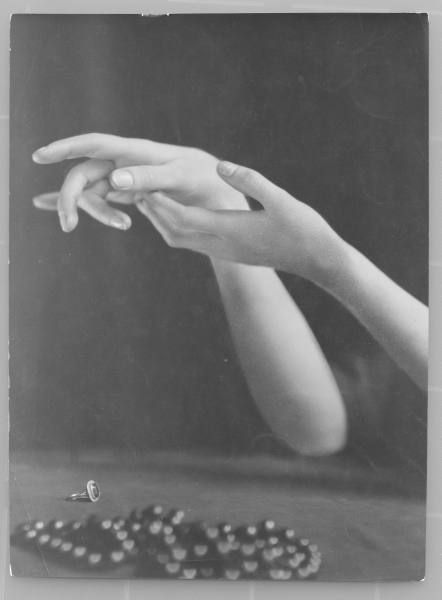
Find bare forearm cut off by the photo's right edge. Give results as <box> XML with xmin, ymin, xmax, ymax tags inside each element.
<box><xmin>319</xmin><ymin>242</ymin><xmax>428</xmax><ymax>388</ymax></box>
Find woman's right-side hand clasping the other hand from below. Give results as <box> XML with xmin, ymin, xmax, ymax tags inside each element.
<box><xmin>138</xmin><ymin>162</ymin><xmax>345</xmax><ymax>285</ymax></box>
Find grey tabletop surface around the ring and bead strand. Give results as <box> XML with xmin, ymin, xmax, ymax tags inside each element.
<box><xmin>10</xmin><ymin>453</ymin><xmax>425</xmax><ymax>581</ymax></box>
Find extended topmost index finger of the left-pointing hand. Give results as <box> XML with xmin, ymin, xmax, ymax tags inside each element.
<box><xmin>32</xmin><ymin>133</ymin><xmax>178</xmax><ymax>164</ymax></box>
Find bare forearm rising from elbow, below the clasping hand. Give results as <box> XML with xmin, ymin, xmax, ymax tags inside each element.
<box><xmin>212</xmin><ymin>261</ymin><xmax>346</xmax><ymax>455</ymax></box>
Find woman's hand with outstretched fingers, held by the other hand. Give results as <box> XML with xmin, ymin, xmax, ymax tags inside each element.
<box><xmin>33</xmin><ymin>133</ymin><xmax>248</xmax><ymax>232</ymax></box>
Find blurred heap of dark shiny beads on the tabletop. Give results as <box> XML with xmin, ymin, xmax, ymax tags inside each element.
<box><xmin>11</xmin><ymin>504</ymin><xmax>321</xmax><ymax>581</ymax></box>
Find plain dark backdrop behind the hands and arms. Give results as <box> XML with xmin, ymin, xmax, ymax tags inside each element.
<box><xmin>10</xmin><ymin>14</ymin><xmax>428</xmax><ymax>473</ymax></box>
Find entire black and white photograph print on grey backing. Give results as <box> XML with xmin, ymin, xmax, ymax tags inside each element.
<box><xmin>9</xmin><ymin>13</ymin><xmax>428</xmax><ymax>588</ymax></box>
